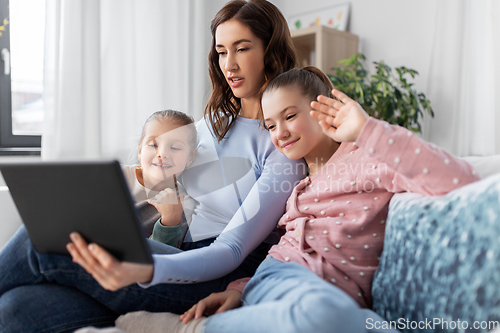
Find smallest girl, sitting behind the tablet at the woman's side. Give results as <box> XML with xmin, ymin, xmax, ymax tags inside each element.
<box><xmin>122</xmin><ymin>110</ymin><xmax>197</xmax><ymax>246</ymax></box>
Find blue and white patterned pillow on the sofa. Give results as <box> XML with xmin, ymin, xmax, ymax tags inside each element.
<box><xmin>372</xmin><ymin>174</ymin><xmax>500</xmax><ymax>332</ymax></box>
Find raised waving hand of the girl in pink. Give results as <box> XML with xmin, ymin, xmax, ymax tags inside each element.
<box><xmin>311</xmin><ymin>89</ymin><xmax>369</xmax><ymax>142</ymax></box>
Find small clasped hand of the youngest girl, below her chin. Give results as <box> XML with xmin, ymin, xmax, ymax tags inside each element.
<box><xmin>148</xmin><ymin>188</ymin><xmax>184</xmax><ymax>227</ymax></box>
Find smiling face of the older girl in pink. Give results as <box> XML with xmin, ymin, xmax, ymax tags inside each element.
<box><xmin>262</xmin><ymin>86</ymin><xmax>332</xmax><ymax>165</ymax></box>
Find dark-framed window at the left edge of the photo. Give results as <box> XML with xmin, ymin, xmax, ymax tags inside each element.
<box><xmin>0</xmin><ymin>0</ymin><xmax>45</xmax><ymax>155</ymax></box>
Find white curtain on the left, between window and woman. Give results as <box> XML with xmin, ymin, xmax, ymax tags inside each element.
<box><xmin>42</xmin><ymin>0</ymin><xmax>212</xmax><ymax>163</ymax></box>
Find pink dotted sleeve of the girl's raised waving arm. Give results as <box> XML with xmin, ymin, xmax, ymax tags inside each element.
<box><xmin>356</xmin><ymin>118</ymin><xmax>479</xmax><ymax>195</ymax></box>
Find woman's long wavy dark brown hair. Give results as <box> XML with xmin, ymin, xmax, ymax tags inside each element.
<box><xmin>205</xmin><ymin>0</ymin><xmax>297</xmax><ymax>142</ymax></box>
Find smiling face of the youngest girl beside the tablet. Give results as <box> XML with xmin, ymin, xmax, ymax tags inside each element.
<box><xmin>139</xmin><ymin>119</ymin><xmax>196</xmax><ymax>189</ymax></box>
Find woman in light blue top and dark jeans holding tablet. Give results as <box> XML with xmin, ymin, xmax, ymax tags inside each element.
<box><xmin>0</xmin><ymin>0</ymin><xmax>305</xmax><ymax>332</ymax></box>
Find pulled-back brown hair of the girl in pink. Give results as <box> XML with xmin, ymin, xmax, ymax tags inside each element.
<box><xmin>264</xmin><ymin>66</ymin><xmax>334</xmax><ymax>101</ymax></box>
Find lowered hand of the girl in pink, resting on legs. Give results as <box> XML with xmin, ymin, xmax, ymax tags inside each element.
<box><xmin>180</xmin><ymin>289</ymin><xmax>241</xmax><ymax>324</ymax></box>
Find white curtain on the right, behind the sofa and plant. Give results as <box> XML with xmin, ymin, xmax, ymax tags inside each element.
<box><xmin>425</xmin><ymin>0</ymin><xmax>500</xmax><ymax>156</ymax></box>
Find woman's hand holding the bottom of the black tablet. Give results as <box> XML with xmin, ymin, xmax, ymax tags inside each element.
<box><xmin>66</xmin><ymin>232</ymin><xmax>154</xmax><ymax>291</ymax></box>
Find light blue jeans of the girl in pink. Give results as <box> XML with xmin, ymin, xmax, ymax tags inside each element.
<box><xmin>202</xmin><ymin>257</ymin><xmax>397</xmax><ymax>333</ymax></box>
